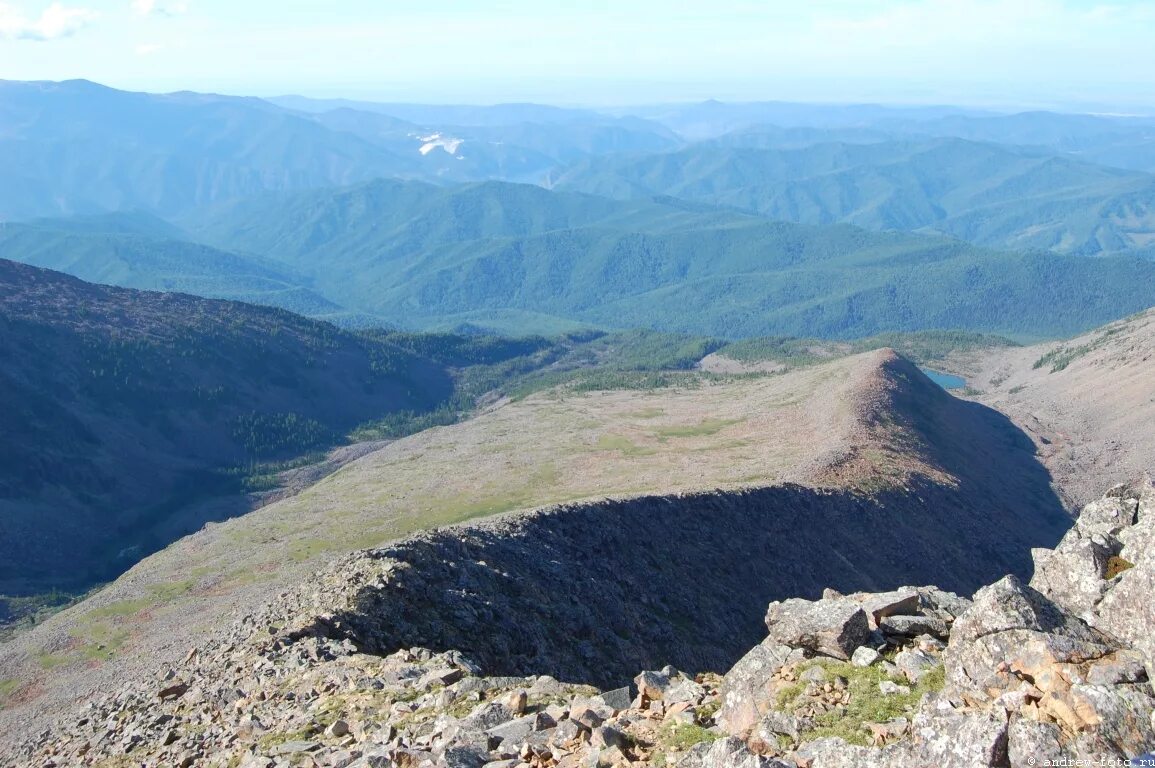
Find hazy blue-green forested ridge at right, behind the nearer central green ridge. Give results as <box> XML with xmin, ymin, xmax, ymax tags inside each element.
<box><xmin>553</xmin><ymin>139</ymin><xmax>1155</xmax><ymax>255</ymax></box>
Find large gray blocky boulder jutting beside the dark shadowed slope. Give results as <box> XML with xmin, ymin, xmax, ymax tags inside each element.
<box><xmin>766</xmin><ymin>597</ymin><xmax>870</xmax><ymax>661</ymax></box>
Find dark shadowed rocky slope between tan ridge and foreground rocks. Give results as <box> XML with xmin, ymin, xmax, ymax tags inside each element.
<box><xmin>283</xmin><ymin>475</ymin><xmax>1061</xmax><ymax>687</ymax></box>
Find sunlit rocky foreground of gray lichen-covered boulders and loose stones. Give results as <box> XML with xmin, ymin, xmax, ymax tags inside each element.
<box><xmin>21</xmin><ymin>482</ymin><xmax>1155</xmax><ymax>768</ymax></box>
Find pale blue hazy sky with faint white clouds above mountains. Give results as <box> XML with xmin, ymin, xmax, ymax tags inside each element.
<box><xmin>0</xmin><ymin>0</ymin><xmax>1155</xmax><ymax>107</ymax></box>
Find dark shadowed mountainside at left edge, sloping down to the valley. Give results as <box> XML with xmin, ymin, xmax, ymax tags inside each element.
<box><xmin>0</xmin><ymin>260</ymin><xmax>454</xmax><ymax>595</ymax></box>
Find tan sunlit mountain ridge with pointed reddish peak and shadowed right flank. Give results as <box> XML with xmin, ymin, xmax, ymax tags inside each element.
<box><xmin>0</xmin><ymin>351</ymin><xmax>1068</xmax><ymax>757</ymax></box>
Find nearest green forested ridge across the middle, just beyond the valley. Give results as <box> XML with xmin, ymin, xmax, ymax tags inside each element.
<box><xmin>187</xmin><ymin>181</ymin><xmax>1155</xmax><ymax>337</ymax></box>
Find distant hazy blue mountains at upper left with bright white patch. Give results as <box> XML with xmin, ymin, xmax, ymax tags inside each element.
<box><xmin>0</xmin><ymin>81</ymin><xmax>677</xmax><ymax>221</ymax></box>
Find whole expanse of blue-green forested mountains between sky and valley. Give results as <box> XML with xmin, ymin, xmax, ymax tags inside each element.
<box><xmin>0</xmin><ymin>81</ymin><xmax>1155</xmax><ymax>338</ymax></box>
